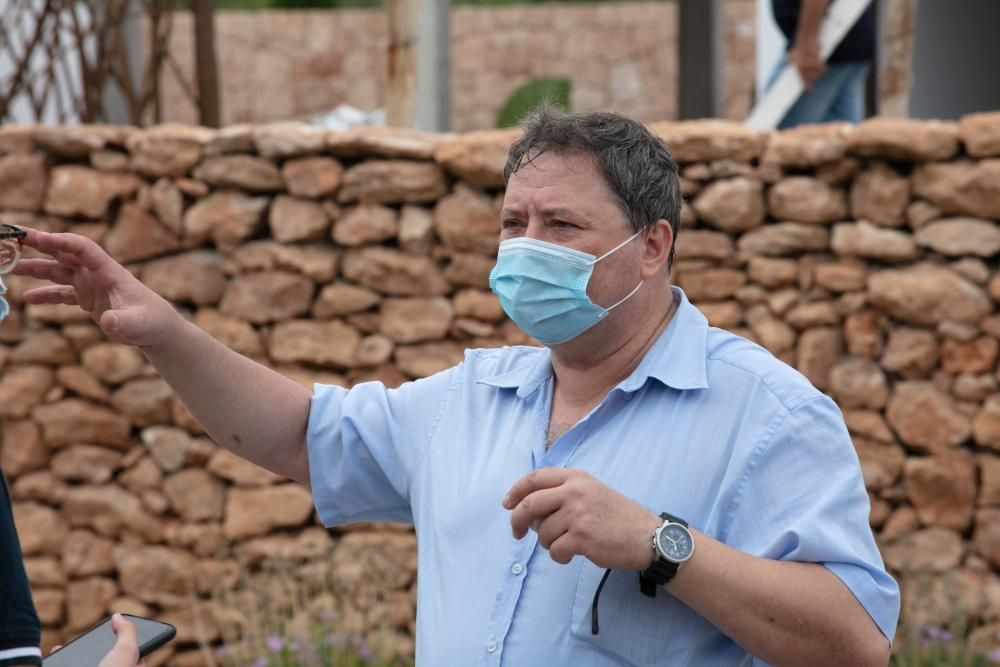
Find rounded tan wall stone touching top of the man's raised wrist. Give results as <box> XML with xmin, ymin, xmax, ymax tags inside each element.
<box><xmin>139</xmin><ymin>250</ymin><xmax>226</xmax><ymax>306</ymax></box>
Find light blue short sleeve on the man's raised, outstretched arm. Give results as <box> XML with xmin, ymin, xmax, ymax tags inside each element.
<box><xmin>306</xmin><ymin>367</ymin><xmax>460</xmax><ymax>526</ymax></box>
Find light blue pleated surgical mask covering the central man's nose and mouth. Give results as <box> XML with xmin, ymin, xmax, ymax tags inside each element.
<box><xmin>490</xmin><ymin>232</ymin><xmax>642</xmax><ymax>345</ymax></box>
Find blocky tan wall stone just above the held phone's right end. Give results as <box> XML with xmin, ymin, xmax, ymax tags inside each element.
<box><xmin>112</xmin><ymin>544</ymin><xmax>196</xmax><ymax>607</ymax></box>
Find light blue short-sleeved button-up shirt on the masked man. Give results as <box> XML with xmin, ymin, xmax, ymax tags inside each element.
<box><xmin>308</xmin><ymin>288</ymin><xmax>899</xmax><ymax>667</ymax></box>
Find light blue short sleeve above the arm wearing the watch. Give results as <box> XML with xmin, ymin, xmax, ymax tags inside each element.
<box><xmin>721</xmin><ymin>396</ymin><xmax>899</xmax><ymax>641</ymax></box>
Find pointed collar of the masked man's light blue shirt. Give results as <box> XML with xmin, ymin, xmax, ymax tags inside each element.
<box><xmin>479</xmin><ymin>287</ymin><xmax>708</xmax><ymax>398</ymax></box>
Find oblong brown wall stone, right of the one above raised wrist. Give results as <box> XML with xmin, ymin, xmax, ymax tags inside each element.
<box><xmin>219</xmin><ymin>271</ymin><xmax>314</xmax><ymax>324</ymax></box>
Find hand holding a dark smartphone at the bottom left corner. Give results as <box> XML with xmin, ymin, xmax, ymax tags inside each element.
<box><xmin>42</xmin><ymin>614</ymin><xmax>177</xmax><ymax>667</ymax></box>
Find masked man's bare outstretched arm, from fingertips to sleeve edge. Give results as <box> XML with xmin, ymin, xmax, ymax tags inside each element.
<box><xmin>15</xmin><ymin>230</ymin><xmax>311</xmax><ymax>482</ymax></box>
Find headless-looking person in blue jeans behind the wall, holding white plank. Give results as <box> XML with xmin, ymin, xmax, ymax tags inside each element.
<box><xmin>769</xmin><ymin>0</ymin><xmax>876</xmax><ymax>130</ymax></box>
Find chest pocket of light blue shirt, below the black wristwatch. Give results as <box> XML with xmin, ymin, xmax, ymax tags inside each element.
<box><xmin>570</xmin><ymin>560</ymin><xmax>685</xmax><ymax>665</ymax></box>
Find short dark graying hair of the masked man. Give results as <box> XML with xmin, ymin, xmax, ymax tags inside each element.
<box><xmin>503</xmin><ymin>105</ymin><xmax>681</xmax><ymax>271</ymax></box>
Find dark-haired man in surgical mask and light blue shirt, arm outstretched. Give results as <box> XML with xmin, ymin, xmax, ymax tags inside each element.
<box><xmin>18</xmin><ymin>110</ymin><xmax>899</xmax><ymax>667</ymax></box>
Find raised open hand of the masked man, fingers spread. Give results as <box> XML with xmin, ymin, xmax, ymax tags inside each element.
<box><xmin>14</xmin><ymin>229</ymin><xmax>183</xmax><ymax>347</ymax></box>
